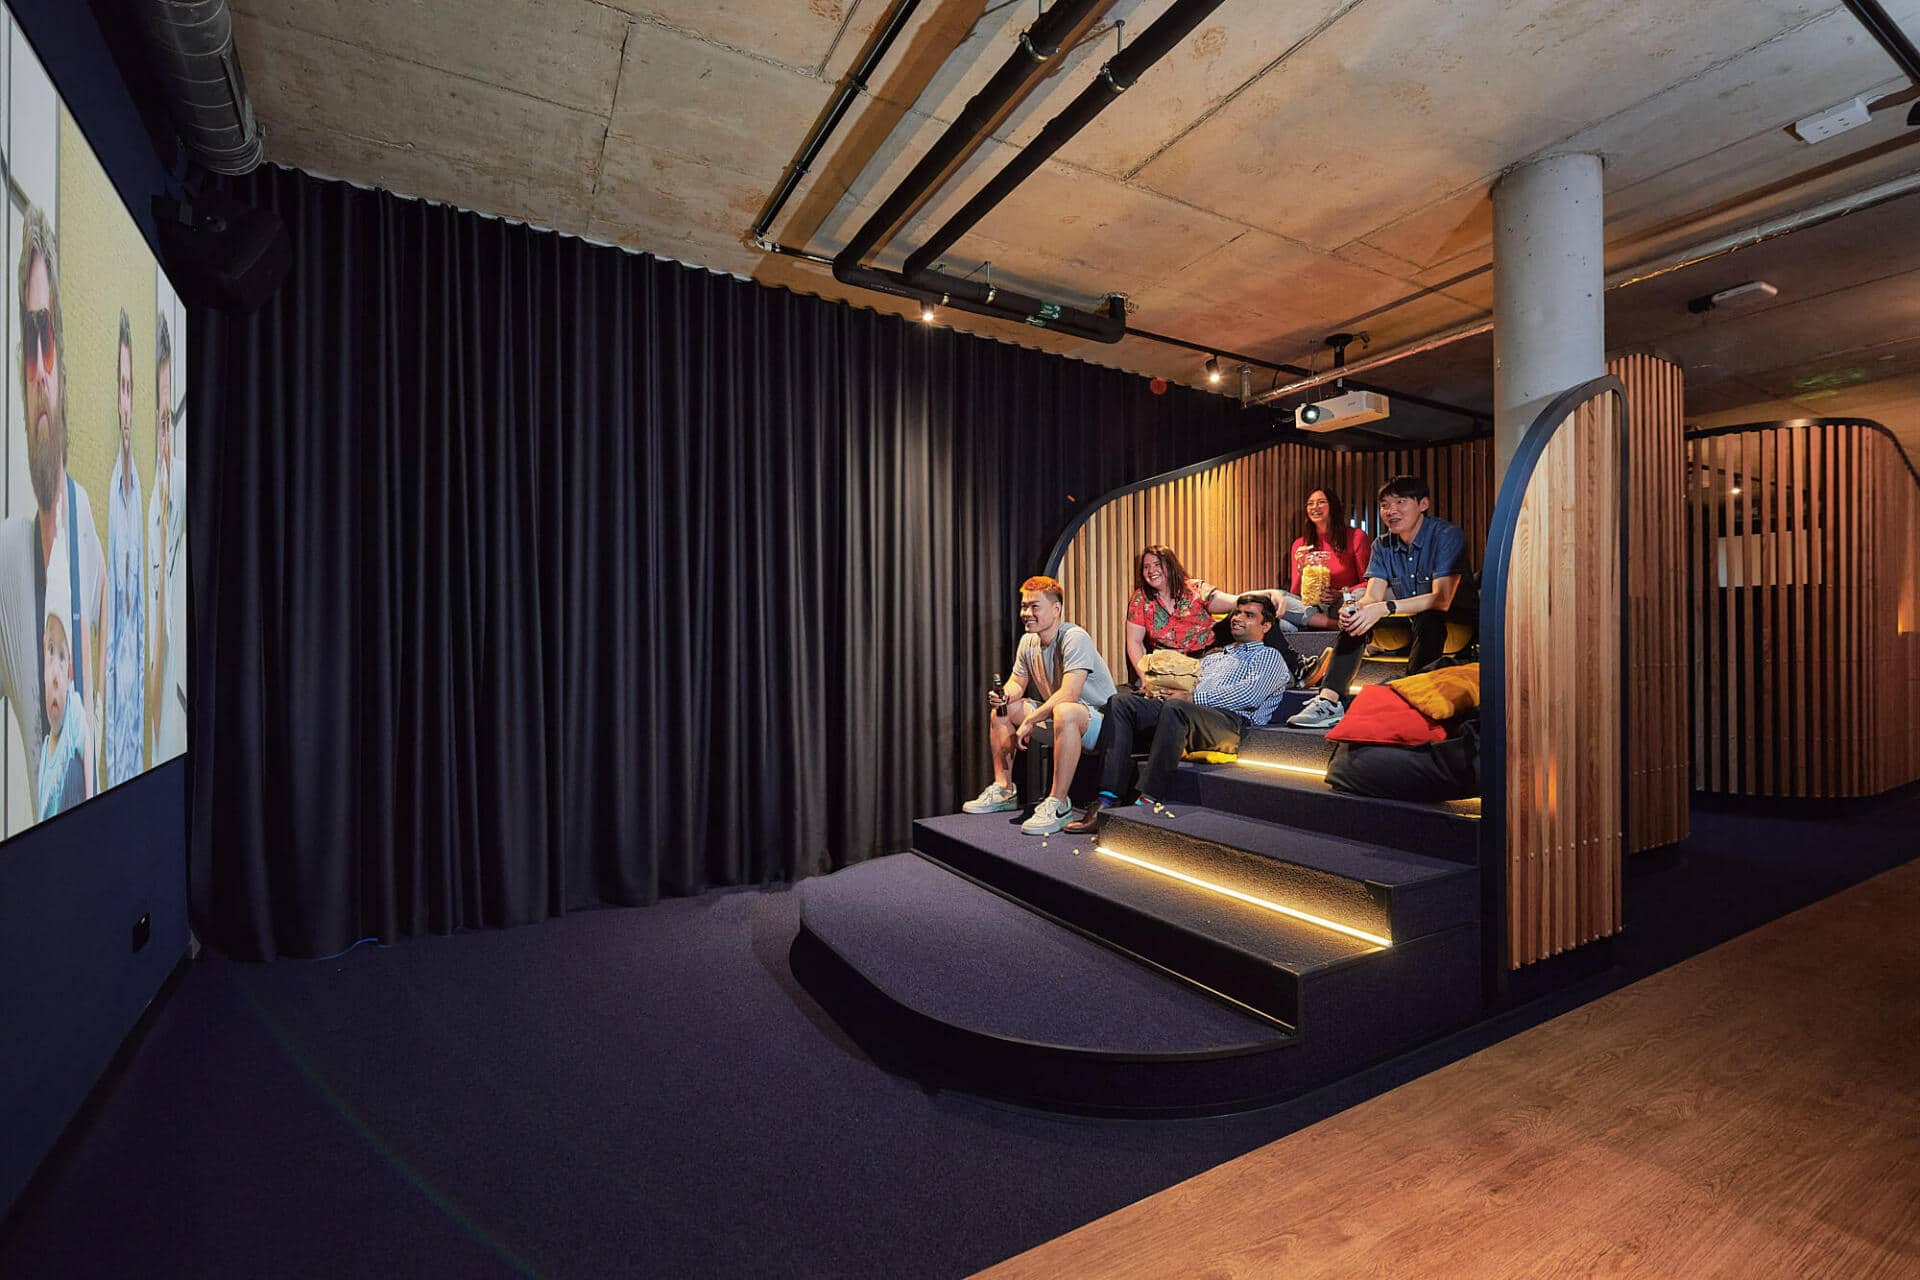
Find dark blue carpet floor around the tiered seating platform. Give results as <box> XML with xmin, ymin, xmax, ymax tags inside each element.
<box><xmin>0</xmin><ymin>794</ymin><xmax>1920</xmax><ymax>1276</ymax></box>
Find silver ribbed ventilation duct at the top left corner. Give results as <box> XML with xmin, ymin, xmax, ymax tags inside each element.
<box><xmin>132</xmin><ymin>0</ymin><xmax>265</xmax><ymax>173</ymax></box>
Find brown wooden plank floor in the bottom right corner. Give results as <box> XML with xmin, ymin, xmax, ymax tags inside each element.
<box><xmin>983</xmin><ymin>864</ymin><xmax>1920</xmax><ymax>1280</ymax></box>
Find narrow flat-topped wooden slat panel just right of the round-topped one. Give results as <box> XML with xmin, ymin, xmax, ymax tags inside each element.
<box><xmin>1607</xmin><ymin>355</ymin><xmax>1692</xmax><ymax>854</ymax></box>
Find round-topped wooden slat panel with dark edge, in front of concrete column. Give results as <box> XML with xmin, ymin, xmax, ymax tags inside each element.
<box><xmin>1505</xmin><ymin>391</ymin><xmax>1626</xmax><ymax>969</ymax></box>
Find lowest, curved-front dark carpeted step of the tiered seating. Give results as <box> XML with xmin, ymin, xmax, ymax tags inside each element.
<box><xmin>791</xmin><ymin>855</ymin><xmax>1478</xmax><ymax>1113</ymax></box>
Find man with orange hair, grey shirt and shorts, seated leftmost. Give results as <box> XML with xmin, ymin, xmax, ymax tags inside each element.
<box><xmin>960</xmin><ymin>578</ymin><xmax>1114</xmax><ymax>835</ymax></box>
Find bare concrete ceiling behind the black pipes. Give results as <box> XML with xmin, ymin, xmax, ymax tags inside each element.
<box><xmin>232</xmin><ymin>0</ymin><xmax>1920</xmax><ymax>453</ymax></box>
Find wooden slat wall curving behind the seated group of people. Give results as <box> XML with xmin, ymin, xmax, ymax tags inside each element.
<box><xmin>1058</xmin><ymin>439</ymin><xmax>1494</xmax><ymax>681</ymax></box>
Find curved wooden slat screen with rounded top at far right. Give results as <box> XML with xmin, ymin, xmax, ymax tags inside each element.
<box><xmin>1688</xmin><ymin>418</ymin><xmax>1920</xmax><ymax>796</ymax></box>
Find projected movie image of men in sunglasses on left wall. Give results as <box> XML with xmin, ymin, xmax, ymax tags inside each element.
<box><xmin>0</xmin><ymin>10</ymin><xmax>186</xmax><ymax>837</ymax></box>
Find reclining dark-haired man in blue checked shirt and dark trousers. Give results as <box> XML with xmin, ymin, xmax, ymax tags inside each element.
<box><xmin>1066</xmin><ymin>595</ymin><xmax>1292</xmax><ymax>833</ymax></box>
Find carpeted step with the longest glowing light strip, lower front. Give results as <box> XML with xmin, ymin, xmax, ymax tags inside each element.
<box><xmin>1098</xmin><ymin>805</ymin><xmax>1480</xmax><ymax>942</ymax></box>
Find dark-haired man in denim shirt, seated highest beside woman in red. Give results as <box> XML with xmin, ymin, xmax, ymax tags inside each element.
<box><xmin>1286</xmin><ymin>476</ymin><xmax>1467</xmax><ymax>729</ymax></box>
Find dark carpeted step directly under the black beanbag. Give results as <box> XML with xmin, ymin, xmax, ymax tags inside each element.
<box><xmin>1198</xmin><ymin>767</ymin><xmax>1480</xmax><ymax>865</ymax></box>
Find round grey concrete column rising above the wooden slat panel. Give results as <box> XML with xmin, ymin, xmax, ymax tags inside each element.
<box><xmin>1494</xmin><ymin>155</ymin><xmax>1607</xmax><ymax>484</ymax></box>
